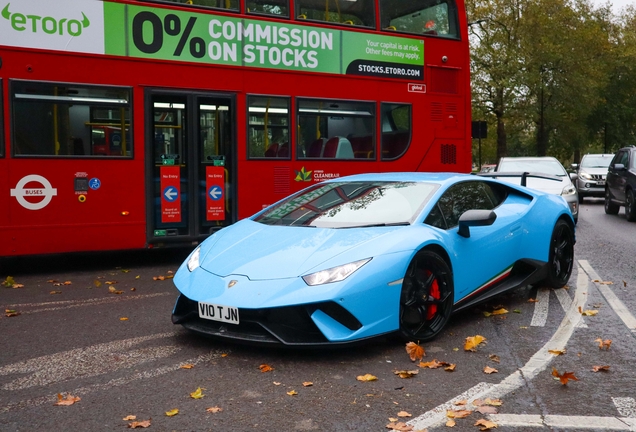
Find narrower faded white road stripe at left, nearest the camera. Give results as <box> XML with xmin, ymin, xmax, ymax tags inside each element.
<box><xmin>0</xmin><ymin>350</ymin><xmax>221</xmax><ymax>413</ymax></box>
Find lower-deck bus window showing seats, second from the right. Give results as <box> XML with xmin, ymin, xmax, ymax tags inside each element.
<box><xmin>296</xmin><ymin>99</ymin><xmax>375</xmax><ymax>160</ymax></box>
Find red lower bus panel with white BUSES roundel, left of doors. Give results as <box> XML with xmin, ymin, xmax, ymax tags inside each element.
<box><xmin>0</xmin><ymin>158</ymin><xmax>146</xmax><ymax>256</ymax></box>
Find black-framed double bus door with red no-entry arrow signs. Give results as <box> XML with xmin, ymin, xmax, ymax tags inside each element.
<box><xmin>146</xmin><ymin>91</ymin><xmax>236</xmax><ymax>244</ymax></box>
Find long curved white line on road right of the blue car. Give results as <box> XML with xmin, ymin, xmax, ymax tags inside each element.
<box><xmin>407</xmin><ymin>264</ymin><xmax>588</xmax><ymax>429</ymax></box>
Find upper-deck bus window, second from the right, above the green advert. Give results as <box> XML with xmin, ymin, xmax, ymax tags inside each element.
<box><xmin>295</xmin><ymin>0</ymin><xmax>376</xmax><ymax>27</ymax></box>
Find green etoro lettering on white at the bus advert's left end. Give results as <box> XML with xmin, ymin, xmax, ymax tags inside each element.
<box><xmin>2</xmin><ymin>3</ymin><xmax>91</xmax><ymax>36</ymax></box>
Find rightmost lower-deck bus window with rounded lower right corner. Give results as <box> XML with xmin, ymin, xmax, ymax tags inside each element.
<box><xmin>382</xmin><ymin>103</ymin><xmax>412</xmax><ymax>160</ymax></box>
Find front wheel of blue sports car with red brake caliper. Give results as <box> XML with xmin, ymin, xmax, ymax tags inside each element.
<box><xmin>400</xmin><ymin>251</ymin><xmax>454</xmax><ymax>341</ymax></box>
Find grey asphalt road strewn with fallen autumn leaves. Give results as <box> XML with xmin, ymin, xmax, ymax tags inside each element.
<box><xmin>0</xmin><ymin>200</ymin><xmax>636</xmax><ymax>431</ymax></box>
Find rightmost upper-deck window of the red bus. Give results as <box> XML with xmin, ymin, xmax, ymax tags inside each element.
<box><xmin>380</xmin><ymin>0</ymin><xmax>459</xmax><ymax>38</ymax></box>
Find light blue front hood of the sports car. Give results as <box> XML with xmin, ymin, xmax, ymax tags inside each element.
<box><xmin>201</xmin><ymin>219</ymin><xmax>407</xmax><ymax>280</ymax></box>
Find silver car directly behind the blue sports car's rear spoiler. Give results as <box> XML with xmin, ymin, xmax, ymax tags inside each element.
<box><xmin>495</xmin><ymin>156</ymin><xmax>580</xmax><ymax>223</ymax></box>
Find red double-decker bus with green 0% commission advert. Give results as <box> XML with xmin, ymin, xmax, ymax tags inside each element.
<box><xmin>0</xmin><ymin>0</ymin><xmax>472</xmax><ymax>256</ymax></box>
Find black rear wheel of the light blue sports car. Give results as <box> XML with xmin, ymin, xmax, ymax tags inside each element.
<box><xmin>542</xmin><ymin>220</ymin><xmax>574</xmax><ymax>288</ymax></box>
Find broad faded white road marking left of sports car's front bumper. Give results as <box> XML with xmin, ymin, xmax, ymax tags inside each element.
<box><xmin>0</xmin><ymin>333</ymin><xmax>180</xmax><ymax>390</ymax></box>
